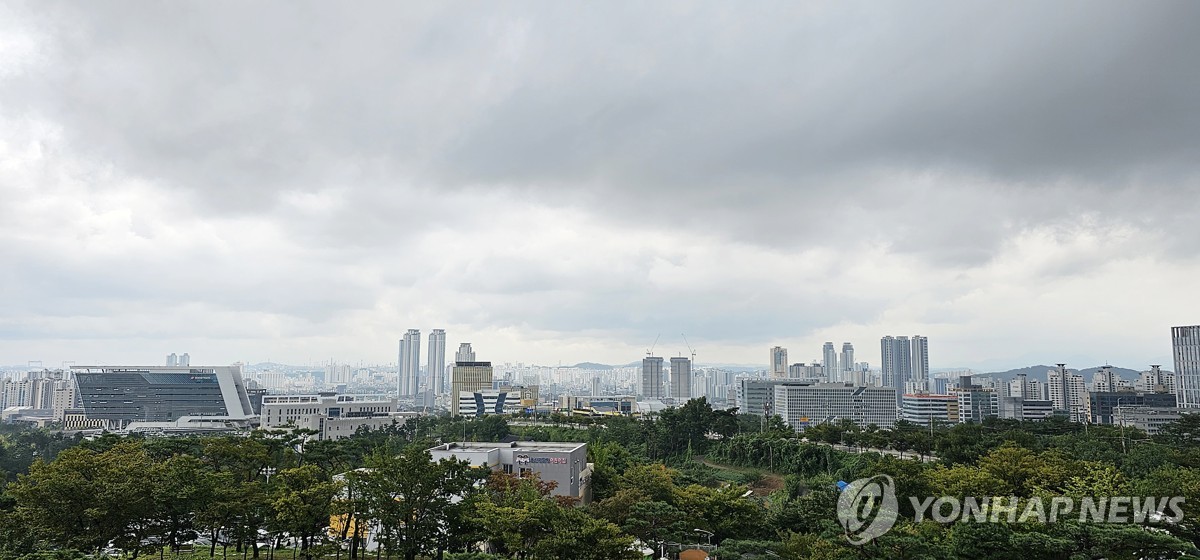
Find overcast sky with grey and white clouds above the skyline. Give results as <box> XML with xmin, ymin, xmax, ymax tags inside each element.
<box><xmin>0</xmin><ymin>0</ymin><xmax>1200</xmax><ymax>371</ymax></box>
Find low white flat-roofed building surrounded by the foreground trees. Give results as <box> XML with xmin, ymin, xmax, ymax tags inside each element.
<box><xmin>430</xmin><ymin>441</ymin><xmax>592</xmax><ymax>504</ymax></box>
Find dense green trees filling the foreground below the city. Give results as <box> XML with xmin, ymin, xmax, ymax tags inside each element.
<box><xmin>0</xmin><ymin>399</ymin><xmax>1200</xmax><ymax>560</ymax></box>
